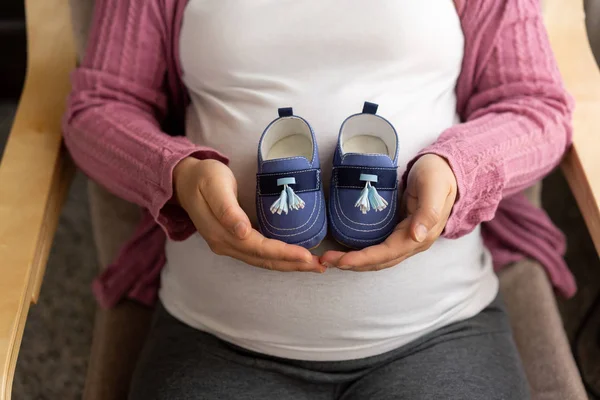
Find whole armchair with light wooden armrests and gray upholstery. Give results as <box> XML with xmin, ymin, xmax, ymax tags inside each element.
<box><xmin>0</xmin><ymin>0</ymin><xmax>600</xmax><ymax>400</ymax></box>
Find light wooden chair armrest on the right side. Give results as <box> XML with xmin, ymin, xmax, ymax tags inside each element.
<box><xmin>544</xmin><ymin>0</ymin><xmax>600</xmax><ymax>253</ymax></box>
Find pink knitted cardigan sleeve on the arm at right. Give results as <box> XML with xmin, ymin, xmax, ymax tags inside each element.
<box><xmin>404</xmin><ymin>0</ymin><xmax>573</xmax><ymax>238</ymax></box>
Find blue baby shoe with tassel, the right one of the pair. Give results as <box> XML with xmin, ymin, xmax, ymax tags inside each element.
<box><xmin>329</xmin><ymin>102</ymin><xmax>399</xmax><ymax>249</ymax></box>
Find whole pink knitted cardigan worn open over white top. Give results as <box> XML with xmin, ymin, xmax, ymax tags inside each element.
<box><xmin>64</xmin><ymin>0</ymin><xmax>576</xmax><ymax>307</ymax></box>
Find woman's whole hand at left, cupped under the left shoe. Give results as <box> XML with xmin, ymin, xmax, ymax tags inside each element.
<box><xmin>173</xmin><ymin>157</ymin><xmax>325</xmax><ymax>272</ymax></box>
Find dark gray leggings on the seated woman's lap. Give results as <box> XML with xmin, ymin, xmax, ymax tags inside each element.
<box><xmin>130</xmin><ymin>298</ymin><xmax>529</xmax><ymax>400</ymax></box>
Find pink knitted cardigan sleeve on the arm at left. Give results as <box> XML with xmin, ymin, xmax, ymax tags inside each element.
<box><xmin>63</xmin><ymin>0</ymin><xmax>227</xmax><ymax>239</ymax></box>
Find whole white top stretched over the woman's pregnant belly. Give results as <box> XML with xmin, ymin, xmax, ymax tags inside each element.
<box><xmin>160</xmin><ymin>0</ymin><xmax>498</xmax><ymax>361</ymax></box>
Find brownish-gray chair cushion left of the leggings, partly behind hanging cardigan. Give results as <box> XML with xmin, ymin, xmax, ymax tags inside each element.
<box><xmin>83</xmin><ymin>181</ymin><xmax>153</xmax><ymax>400</ymax></box>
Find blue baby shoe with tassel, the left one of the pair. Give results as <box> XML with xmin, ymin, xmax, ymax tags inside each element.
<box><xmin>256</xmin><ymin>108</ymin><xmax>327</xmax><ymax>249</ymax></box>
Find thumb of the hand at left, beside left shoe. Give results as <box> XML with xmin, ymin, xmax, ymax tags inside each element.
<box><xmin>200</xmin><ymin>171</ymin><xmax>251</xmax><ymax>239</ymax></box>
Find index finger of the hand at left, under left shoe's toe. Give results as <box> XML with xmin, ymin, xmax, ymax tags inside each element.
<box><xmin>228</xmin><ymin>229</ymin><xmax>313</xmax><ymax>263</ymax></box>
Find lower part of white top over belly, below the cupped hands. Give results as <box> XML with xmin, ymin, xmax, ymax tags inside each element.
<box><xmin>160</xmin><ymin>227</ymin><xmax>497</xmax><ymax>360</ymax></box>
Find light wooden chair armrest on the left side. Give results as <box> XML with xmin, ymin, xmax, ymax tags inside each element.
<box><xmin>0</xmin><ymin>0</ymin><xmax>76</xmax><ymax>400</ymax></box>
